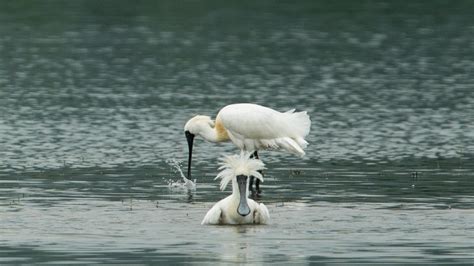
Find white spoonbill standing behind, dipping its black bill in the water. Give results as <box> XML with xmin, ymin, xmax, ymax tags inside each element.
<box><xmin>184</xmin><ymin>103</ymin><xmax>311</xmax><ymax>192</ymax></box>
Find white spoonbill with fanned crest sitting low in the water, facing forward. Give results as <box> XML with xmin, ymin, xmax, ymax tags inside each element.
<box><xmin>201</xmin><ymin>152</ymin><xmax>270</xmax><ymax>224</ymax></box>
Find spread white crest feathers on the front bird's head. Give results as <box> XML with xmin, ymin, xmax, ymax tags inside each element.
<box><xmin>215</xmin><ymin>152</ymin><xmax>265</xmax><ymax>190</ymax></box>
